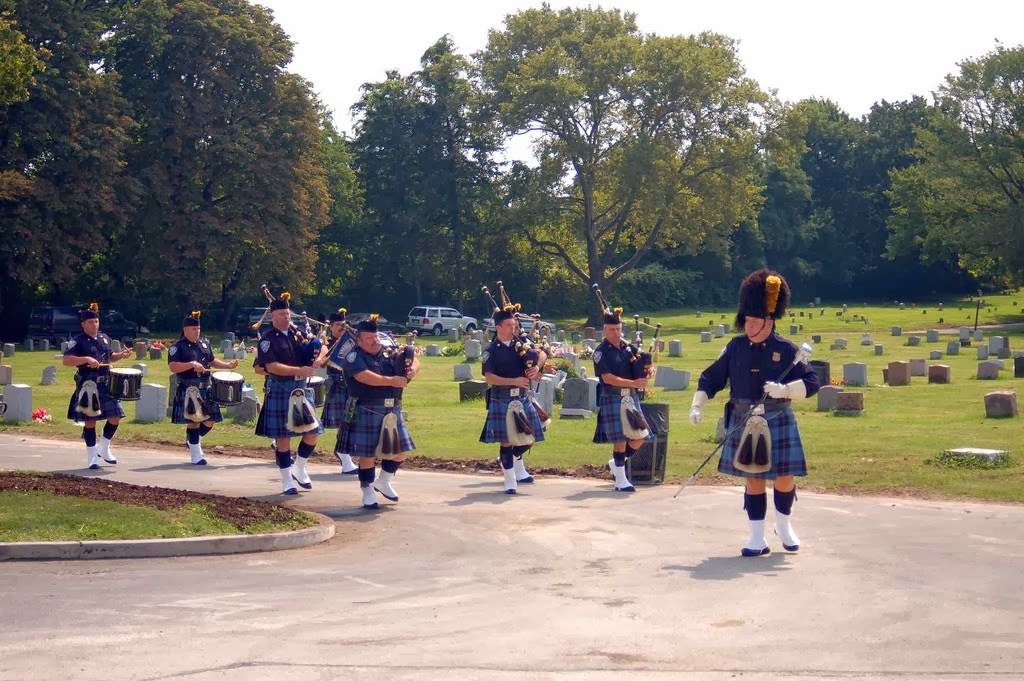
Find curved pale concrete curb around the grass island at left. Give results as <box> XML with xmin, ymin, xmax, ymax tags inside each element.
<box><xmin>0</xmin><ymin>511</ymin><xmax>334</xmax><ymax>562</ymax></box>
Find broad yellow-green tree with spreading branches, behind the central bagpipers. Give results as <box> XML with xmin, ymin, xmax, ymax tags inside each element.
<box><xmin>476</xmin><ymin>5</ymin><xmax>776</xmax><ymax>315</ymax></box>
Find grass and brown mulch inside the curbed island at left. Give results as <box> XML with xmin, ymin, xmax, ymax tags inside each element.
<box><xmin>0</xmin><ymin>471</ymin><xmax>312</xmax><ymax>542</ymax></box>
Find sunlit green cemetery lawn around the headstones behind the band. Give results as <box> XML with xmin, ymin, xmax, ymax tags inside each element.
<box><xmin>0</xmin><ymin>293</ymin><xmax>1024</xmax><ymax>502</ymax></box>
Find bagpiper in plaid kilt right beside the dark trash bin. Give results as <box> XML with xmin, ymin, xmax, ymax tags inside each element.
<box><xmin>594</xmin><ymin>301</ymin><xmax>654</xmax><ymax>492</ymax></box>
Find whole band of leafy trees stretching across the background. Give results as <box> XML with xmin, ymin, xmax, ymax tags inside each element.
<box><xmin>0</xmin><ymin>0</ymin><xmax>1024</xmax><ymax>338</ymax></box>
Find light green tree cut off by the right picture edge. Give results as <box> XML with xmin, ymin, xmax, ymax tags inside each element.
<box><xmin>888</xmin><ymin>45</ymin><xmax>1024</xmax><ymax>285</ymax></box>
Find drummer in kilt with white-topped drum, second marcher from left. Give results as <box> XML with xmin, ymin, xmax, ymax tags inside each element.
<box><xmin>167</xmin><ymin>310</ymin><xmax>239</xmax><ymax>466</ymax></box>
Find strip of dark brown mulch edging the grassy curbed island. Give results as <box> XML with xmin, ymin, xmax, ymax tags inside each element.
<box><xmin>0</xmin><ymin>471</ymin><xmax>297</xmax><ymax>529</ymax></box>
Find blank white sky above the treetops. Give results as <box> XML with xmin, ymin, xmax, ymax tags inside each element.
<box><xmin>254</xmin><ymin>0</ymin><xmax>1024</xmax><ymax>149</ymax></box>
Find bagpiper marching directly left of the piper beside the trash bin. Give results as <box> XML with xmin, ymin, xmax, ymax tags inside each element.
<box><xmin>480</xmin><ymin>305</ymin><xmax>547</xmax><ymax>495</ymax></box>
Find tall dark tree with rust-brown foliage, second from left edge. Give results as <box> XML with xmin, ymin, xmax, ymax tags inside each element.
<box><xmin>111</xmin><ymin>0</ymin><xmax>331</xmax><ymax>317</ymax></box>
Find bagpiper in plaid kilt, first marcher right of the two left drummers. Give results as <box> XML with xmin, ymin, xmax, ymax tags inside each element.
<box><xmin>256</xmin><ymin>292</ymin><xmax>324</xmax><ymax>495</ymax></box>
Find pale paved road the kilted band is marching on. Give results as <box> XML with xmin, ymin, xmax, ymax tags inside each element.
<box><xmin>0</xmin><ymin>435</ymin><xmax>1024</xmax><ymax>681</ymax></box>
